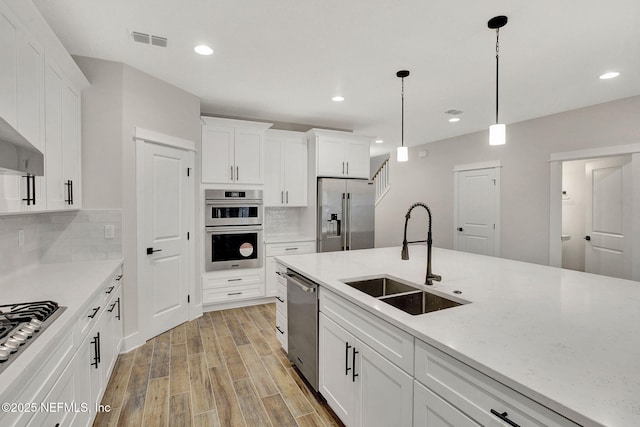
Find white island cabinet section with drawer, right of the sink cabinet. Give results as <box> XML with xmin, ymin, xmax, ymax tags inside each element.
<box><xmin>414</xmin><ymin>340</ymin><xmax>578</xmax><ymax>427</ymax></box>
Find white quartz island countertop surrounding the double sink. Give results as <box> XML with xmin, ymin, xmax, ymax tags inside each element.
<box><xmin>277</xmin><ymin>246</ymin><xmax>640</xmax><ymax>426</ymax></box>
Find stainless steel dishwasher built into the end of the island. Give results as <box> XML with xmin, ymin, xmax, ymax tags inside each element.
<box><xmin>285</xmin><ymin>270</ymin><xmax>318</xmax><ymax>391</ymax></box>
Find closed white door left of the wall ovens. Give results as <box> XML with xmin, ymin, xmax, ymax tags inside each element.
<box><xmin>138</xmin><ymin>142</ymin><xmax>189</xmax><ymax>337</ymax></box>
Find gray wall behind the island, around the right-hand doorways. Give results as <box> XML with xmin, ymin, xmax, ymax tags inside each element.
<box><xmin>376</xmin><ymin>96</ymin><xmax>640</xmax><ymax>264</ymax></box>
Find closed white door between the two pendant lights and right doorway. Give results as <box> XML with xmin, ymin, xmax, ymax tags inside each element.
<box><xmin>454</xmin><ymin>168</ymin><xmax>500</xmax><ymax>256</ymax></box>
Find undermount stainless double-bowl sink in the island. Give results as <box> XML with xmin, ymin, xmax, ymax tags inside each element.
<box><xmin>342</xmin><ymin>276</ymin><xmax>466</xmax><ymax>315</ymax></box>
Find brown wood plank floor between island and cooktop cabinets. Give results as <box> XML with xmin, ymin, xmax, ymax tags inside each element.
<box><xmin>93</xmin><ymin>304</ymin><xmax>342</xmax><ymax>427</ymax></box>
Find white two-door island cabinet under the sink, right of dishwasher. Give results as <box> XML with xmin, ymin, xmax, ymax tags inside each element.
<box><xmin>318</xmin><ymin>288</ymin><xmax>413</xmax><ymax>427</ymax></box>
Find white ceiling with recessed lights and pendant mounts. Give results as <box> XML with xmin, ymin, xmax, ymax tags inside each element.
<box><xmin>34</xmin><ymin>0</ymin><xmax>640</xmax><ymax>155</ymax></box>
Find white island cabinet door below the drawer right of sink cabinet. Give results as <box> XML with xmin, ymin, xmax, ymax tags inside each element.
<box><xmin>413</xmin><ymin>381</ymin><xmax>480</xmax><ymax>427</ymax></box>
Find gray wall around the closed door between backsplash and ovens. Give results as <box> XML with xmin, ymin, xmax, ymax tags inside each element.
<box><xmin>75</xmin><ymin>58</ymin><xmax>200</xmax><ymax>344</ymax></box>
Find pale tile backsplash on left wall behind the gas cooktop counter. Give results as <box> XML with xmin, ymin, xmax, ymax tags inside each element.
<box><xmin>0</xmin><ymin>209</ymin><xmax>122</xmax><ymax>276</ymax></box>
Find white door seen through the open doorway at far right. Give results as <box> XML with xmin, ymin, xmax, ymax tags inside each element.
<box><xmin>585</xmin><ymin>156</ymin><xmax>632</xmax><ymax>279</ymax></box>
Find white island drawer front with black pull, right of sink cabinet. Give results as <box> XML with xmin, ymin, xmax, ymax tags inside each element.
<box><xmin>415</xmin><ymin>340</ymin><xmax>578</xmax><ymax>427</ymax></box>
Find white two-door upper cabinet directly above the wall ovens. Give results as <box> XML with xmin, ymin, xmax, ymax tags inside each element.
<box><xmin>201</xmin><ymin>117</ymin><xmax>271</xmax><ymax>184</ymax></box>
